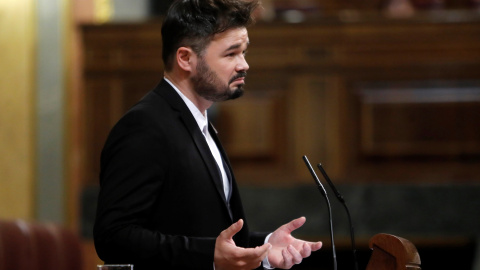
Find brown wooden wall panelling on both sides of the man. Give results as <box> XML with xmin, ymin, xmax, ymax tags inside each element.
<box><xmin>83</xmin><ymin>14</ymin><xmax>480</xmax><ymax>185</ymax></box>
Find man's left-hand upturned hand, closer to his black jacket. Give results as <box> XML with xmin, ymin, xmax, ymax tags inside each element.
<box><xmin>214</xmin><ymin>219</ymin><xmax>271</xmax><ymax>270</ymax></box>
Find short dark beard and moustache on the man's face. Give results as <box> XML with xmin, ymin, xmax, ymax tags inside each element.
<box><xmin>191</xmin><ymin>59</ymin><xmax>247</xmax><ymax>102</ymax></box>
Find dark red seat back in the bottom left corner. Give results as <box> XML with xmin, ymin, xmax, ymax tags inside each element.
<box><xmin>0</xmin><ymin>220</ymin><xmax>83</xmax><ymax>270</ymax></box>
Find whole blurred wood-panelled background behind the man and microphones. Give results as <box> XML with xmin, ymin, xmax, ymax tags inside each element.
<box><xmin>0</xmin><ymin>0</ymin><xmax>480</xmax><ymax>270</ymax></box>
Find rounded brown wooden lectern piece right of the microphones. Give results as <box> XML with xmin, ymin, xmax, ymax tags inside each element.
<box><xmin>366</xmin><ymin>233</ymin><xmax>421</xmax><ymax>270</ymax></box>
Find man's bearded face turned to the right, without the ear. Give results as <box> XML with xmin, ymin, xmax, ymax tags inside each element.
<box><xmin>191</xmin><ymin>28</ymin><xmax>249</xmax><ymax>102</ymax></box>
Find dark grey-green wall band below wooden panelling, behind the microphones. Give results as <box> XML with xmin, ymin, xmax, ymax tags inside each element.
<box><xmin>241</xmin><ymin>184</ymin><xmax>480</xmax><ymax>238</ymax></box>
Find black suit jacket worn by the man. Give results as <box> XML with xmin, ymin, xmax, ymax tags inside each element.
<box><xmin>94</xmin><ymin>80</ymin><xmax>266</xmax><ymax>270</ymax></box>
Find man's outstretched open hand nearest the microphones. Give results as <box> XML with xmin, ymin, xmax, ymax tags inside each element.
<box><xmin>268</xmin><ymin>217</ymin><xmax>322</xmax><ymax>269</ymax></box>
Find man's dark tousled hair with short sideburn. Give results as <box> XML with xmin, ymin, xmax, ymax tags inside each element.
<box><xmin>162</xmin><ymin>0</ymin><xmax>259</xmax><ymax>71</ymax></box>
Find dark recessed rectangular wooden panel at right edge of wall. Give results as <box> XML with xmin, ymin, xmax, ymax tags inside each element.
<box><xmin>360</xmin><ymin>84</ymin><xmax>480</xmax><ymax>157</ymax></box>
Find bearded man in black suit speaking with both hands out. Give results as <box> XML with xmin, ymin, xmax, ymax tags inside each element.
<box><xmin>94</xmin><ymin>0</ymin><xmax>322</xmax><ymax>270</ymax></box>
